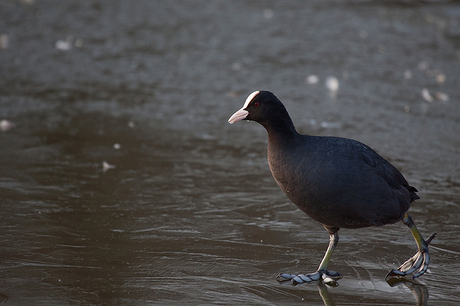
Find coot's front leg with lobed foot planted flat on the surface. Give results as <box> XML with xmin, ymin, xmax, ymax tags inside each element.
<box><xmin>276</xmin><ymin>232</ymin><xmax>342</xmax><ymax>286</ymax></box>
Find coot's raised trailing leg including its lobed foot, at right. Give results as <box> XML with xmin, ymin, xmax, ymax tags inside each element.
<box><xmin>386</xmin><ymin>214</ymin><xmax>436</xmax><ymax>279</ymax></box>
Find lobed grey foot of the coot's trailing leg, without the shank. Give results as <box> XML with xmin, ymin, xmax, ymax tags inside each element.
<box><xmin>385</xmin><ymin>234</ymin><xmax>436</xmax><ymax>279</ymax></box>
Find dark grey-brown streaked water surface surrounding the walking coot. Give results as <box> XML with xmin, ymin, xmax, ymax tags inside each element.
<box><xmin>0</xmin><ymin>0</ymin><xmax>460</xmax><ymax>305</ymax></box>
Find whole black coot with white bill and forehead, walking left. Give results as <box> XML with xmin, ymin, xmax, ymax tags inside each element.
<box><xmin>228</xmin><ymin>91</ymin><xmax>435</xmax><ymax>285</ymax></box>
